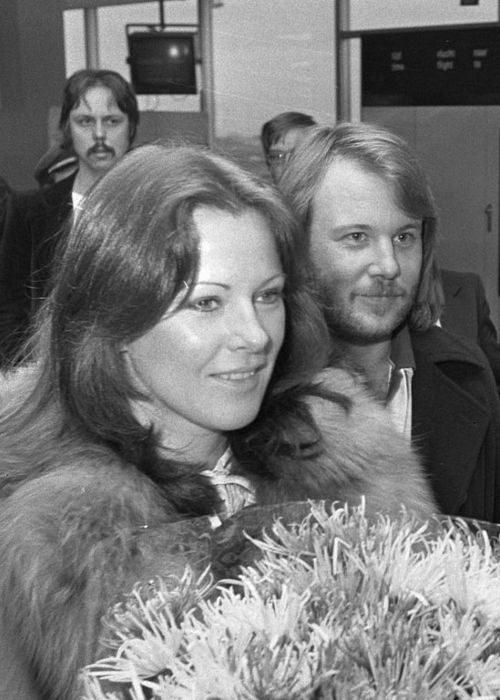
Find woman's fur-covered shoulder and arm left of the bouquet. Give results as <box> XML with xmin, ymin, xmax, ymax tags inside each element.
<box><xmin>0</xmin><ymin>446</ymin><xmax>179</xmax><ymax>698</ymax></box>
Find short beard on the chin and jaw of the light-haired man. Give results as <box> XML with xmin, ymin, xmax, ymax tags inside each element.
<box><xmin>318</xmin><ymin>281</ymin><xmax>418</xmax><ymax>345</ymax></box>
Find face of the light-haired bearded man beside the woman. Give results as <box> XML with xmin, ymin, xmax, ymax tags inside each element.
<box><xmin>310</xmin><ymin>159</ymin><xmax>422</xmax><ymax>345</ymax></box>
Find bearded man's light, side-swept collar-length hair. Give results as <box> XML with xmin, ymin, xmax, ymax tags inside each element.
<box><xmin>280</xmin><ymin>122</ymin><xmax>444</xmax><ymax>331</ymax></box>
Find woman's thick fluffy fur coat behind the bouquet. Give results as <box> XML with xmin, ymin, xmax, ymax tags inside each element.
<box><xmin>0</xmin><ymin>369</ymin><xmax>435</xmax><ymax>700</ymax></box>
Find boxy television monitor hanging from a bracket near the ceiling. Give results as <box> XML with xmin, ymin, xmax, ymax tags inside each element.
<box><xmin>127</xmin><ymin>31</ymin><xmax>197</xmax><ymax>95</ymax></box>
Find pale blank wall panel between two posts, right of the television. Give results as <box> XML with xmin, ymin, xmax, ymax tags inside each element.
<box><xmin>214</xmin><ymin>0</ymin><xmax>336</xmax><ymax>136</ymax></box>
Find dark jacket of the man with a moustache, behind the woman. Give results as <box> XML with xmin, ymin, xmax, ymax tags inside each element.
<box><xmin>0</xmin><ymin>176</ymin><xmax>75</xmax><ymax>367</ymax></box>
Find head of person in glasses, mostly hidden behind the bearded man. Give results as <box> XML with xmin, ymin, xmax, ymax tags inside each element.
<box><xmin>260</xmin><ymin>112</ymin><xmax>316</xmax><ymax>182</ymax></box>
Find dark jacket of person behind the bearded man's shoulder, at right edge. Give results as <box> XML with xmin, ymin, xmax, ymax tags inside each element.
<box><xmin>441</xmin><ymin>270</ymin><xmax>500</xmax><ymax>389</ymax></box>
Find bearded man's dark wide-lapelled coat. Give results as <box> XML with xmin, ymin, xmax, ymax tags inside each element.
<box><xmin>411</xmin><ymin>327</ymin><xmax>500</xmax><ymax>522</ymax></box>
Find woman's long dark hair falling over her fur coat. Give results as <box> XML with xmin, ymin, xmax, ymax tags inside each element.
<box><xmin>0</xmin><ymin>145</ymin><xmax>327</xmax><ymax>512</ymax></box>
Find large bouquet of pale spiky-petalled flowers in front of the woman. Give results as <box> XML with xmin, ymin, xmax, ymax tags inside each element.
<box><xmin>82</xmin><ymin>503</ymin><xmax>500</xmax><ymax>700</ymax></box>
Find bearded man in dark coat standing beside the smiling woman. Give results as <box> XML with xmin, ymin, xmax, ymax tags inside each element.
<box><xmin>279</xmin><ymin>123</ymin><xmax>500</xmax><ymax>522</ymax></box>
